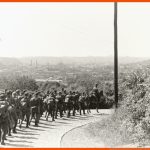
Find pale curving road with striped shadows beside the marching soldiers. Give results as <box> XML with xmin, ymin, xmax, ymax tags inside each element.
<box><xmin>0</xmin><ymin>110</ymin><xmax>112</xmax><ymax>147</ymax></box>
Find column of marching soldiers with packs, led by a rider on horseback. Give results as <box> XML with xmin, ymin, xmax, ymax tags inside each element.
<box><xmin>0</xmin><ymin>85</ymin><xmax>103</xmax><ymax>145</ymax></box>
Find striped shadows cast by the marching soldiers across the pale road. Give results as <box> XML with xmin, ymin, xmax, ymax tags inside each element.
<box><xmin>4</xmin><ymin>113</ymin><xmax>108</xmax><ymax>148</ymax></box>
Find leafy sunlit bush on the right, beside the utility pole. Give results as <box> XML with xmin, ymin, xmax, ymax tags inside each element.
<box><xmin>106</xmin><ymin>71</ymin><xmax>150</xmax><ymax>146</ymax></box>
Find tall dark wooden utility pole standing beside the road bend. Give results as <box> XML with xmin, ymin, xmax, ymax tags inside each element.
<box><xmin>114</xmin><ymin>2</ymin><xmax>118</xmax><ymax>108</ymax></box>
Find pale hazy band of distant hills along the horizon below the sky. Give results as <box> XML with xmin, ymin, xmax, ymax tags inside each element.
<box><xmin>0</xmin><ymin>56</ymin><xmax>150</xmax><ymax>67</ymax></box>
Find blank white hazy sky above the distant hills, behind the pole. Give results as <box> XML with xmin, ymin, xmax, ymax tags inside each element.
<box><xmin>0</xmin><ymin>3</ymin><xmax>150</xmax><ymax>57</ymax></box>
